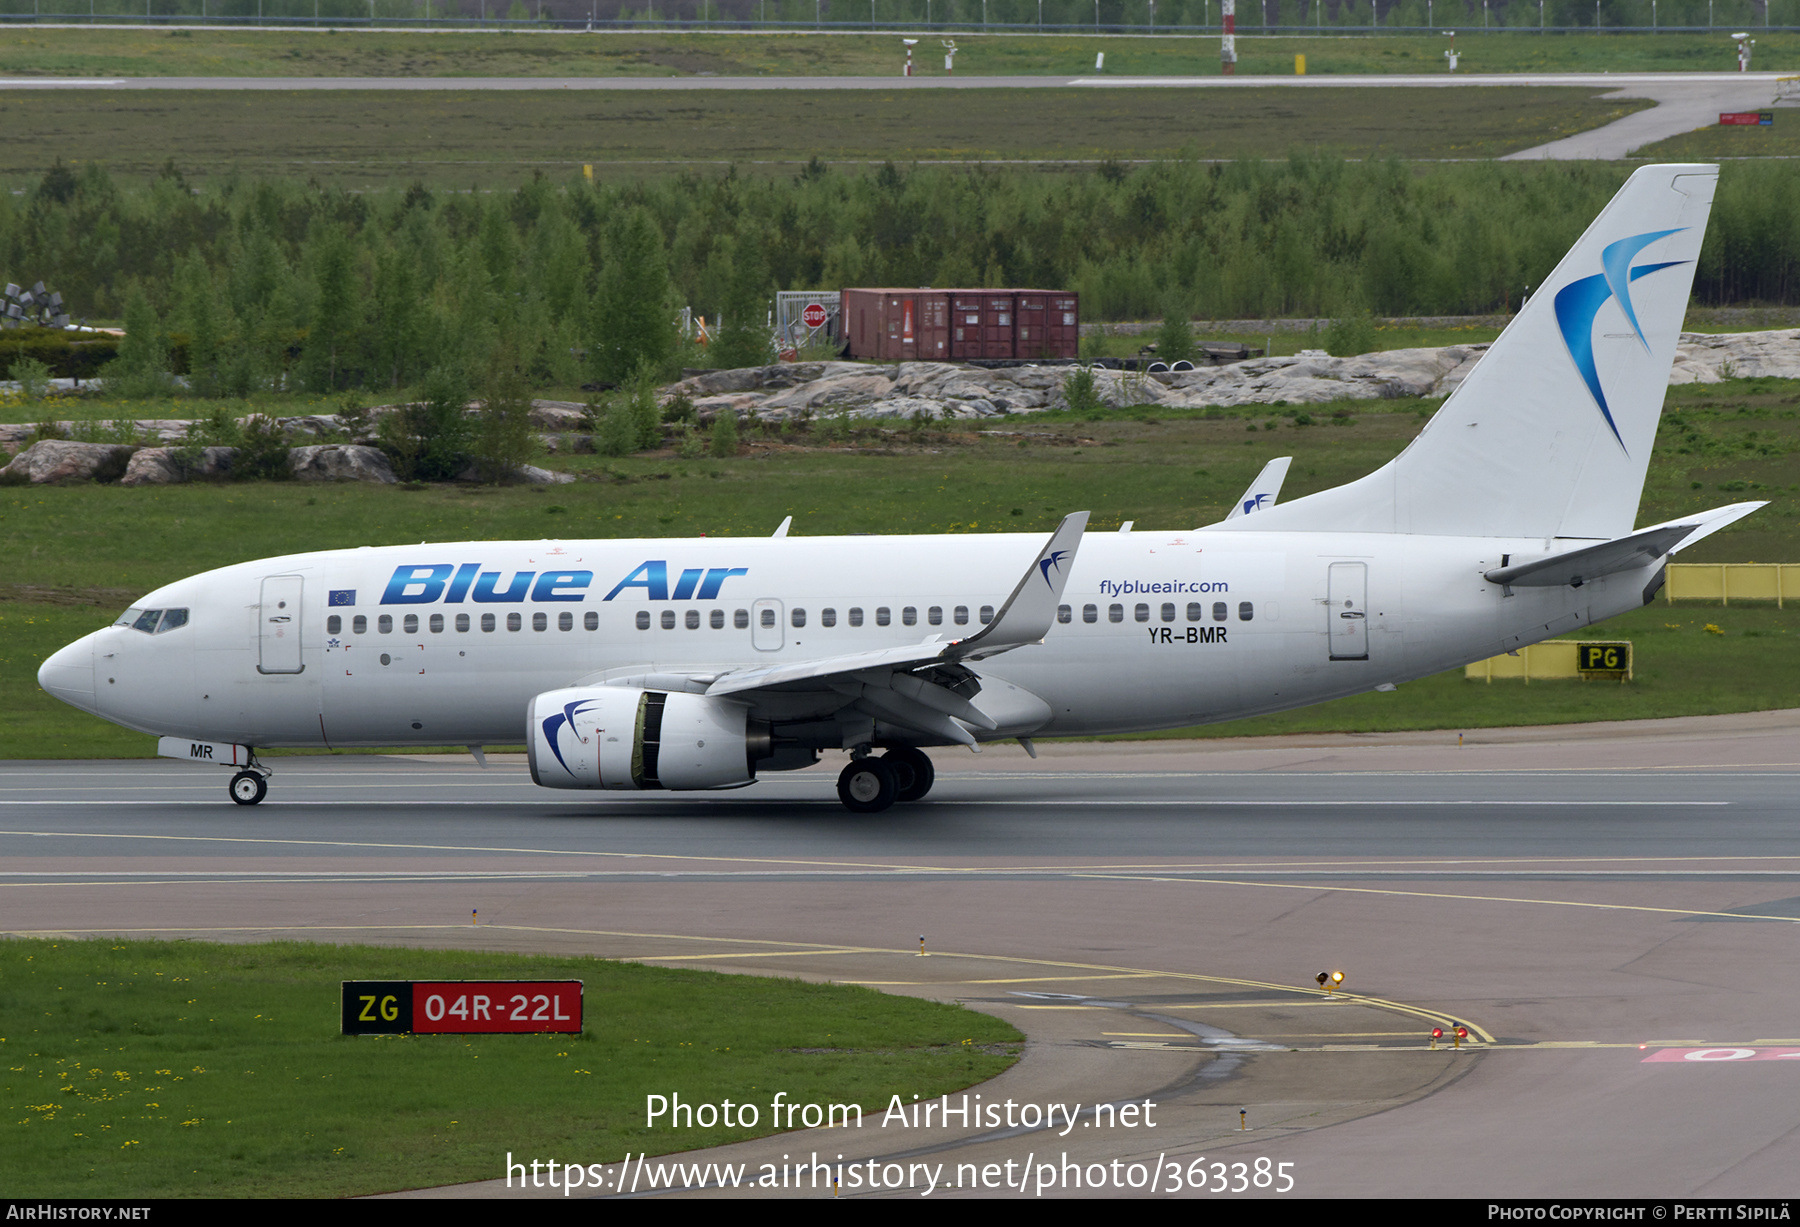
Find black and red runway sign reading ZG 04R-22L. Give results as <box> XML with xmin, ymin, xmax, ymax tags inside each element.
<box><xmin>344</xmin><ymin>981</ymin><xmax>581</xmax><ymax>1034</ymax></box>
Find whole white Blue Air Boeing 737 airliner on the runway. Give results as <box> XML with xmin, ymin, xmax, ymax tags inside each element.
<box><xmin>38</xmin><ymin>166</ymin><xmax>1762</xmax><ymax>813</ymax></box>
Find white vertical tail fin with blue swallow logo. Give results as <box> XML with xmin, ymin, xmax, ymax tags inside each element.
<box><xmin>1220</xmin><ymin>166</ymin><xmax>1719</xmax><ymax>538</ymax></box>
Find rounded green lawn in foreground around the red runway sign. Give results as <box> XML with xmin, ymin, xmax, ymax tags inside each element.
<box><xmin>0</xmin><ymin>939</ymin><xmax>1022</xmax><ymax>1198</ymax></box>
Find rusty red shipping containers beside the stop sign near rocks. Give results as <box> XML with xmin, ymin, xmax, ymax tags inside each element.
<box><xmin>842</xmin><ymin>290</ymin><xmax>1080</xmax><ymax>362</ymax></box>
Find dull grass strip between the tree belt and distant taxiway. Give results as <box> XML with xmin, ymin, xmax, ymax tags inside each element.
<box><xmin>0</xmin><ymin>86</ymin><xmax>1647</xmax><ymax>187</ymax></box>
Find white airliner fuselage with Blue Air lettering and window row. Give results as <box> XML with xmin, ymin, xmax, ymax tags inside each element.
<box><xmin>41</xmin><ymin>531</ymin><xmax>1656</xmax><ymax>747</ymax></box>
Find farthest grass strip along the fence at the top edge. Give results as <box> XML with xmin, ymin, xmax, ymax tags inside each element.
<box><xmin>0</xmin><ymin>26</ymin><xmax>1800</xmax><ymax>77</ymax></box>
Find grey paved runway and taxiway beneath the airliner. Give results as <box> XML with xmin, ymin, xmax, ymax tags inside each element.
<box><xmin>0</xmin><ymin>712</ymin><xmax>1800</xmax><ymax>1196</ymax></box>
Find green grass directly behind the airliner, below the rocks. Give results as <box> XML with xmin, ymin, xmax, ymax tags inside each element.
<box><xmin>0</xmin><ymin>380</ymin><xmax>1800</xmax><ymax>757</ymax></box>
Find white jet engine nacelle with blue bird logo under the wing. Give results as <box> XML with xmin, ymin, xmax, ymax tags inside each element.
<box><xmin>526</xmin><ymin>685</ymin><xmax>769</xmax><ymax>790</ymax></box>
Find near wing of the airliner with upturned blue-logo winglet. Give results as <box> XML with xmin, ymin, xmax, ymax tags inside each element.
<box><xmin>706</xmin><ymin>511</ymin><xmax>1089</xmax><ymax>745</ymax></box>
